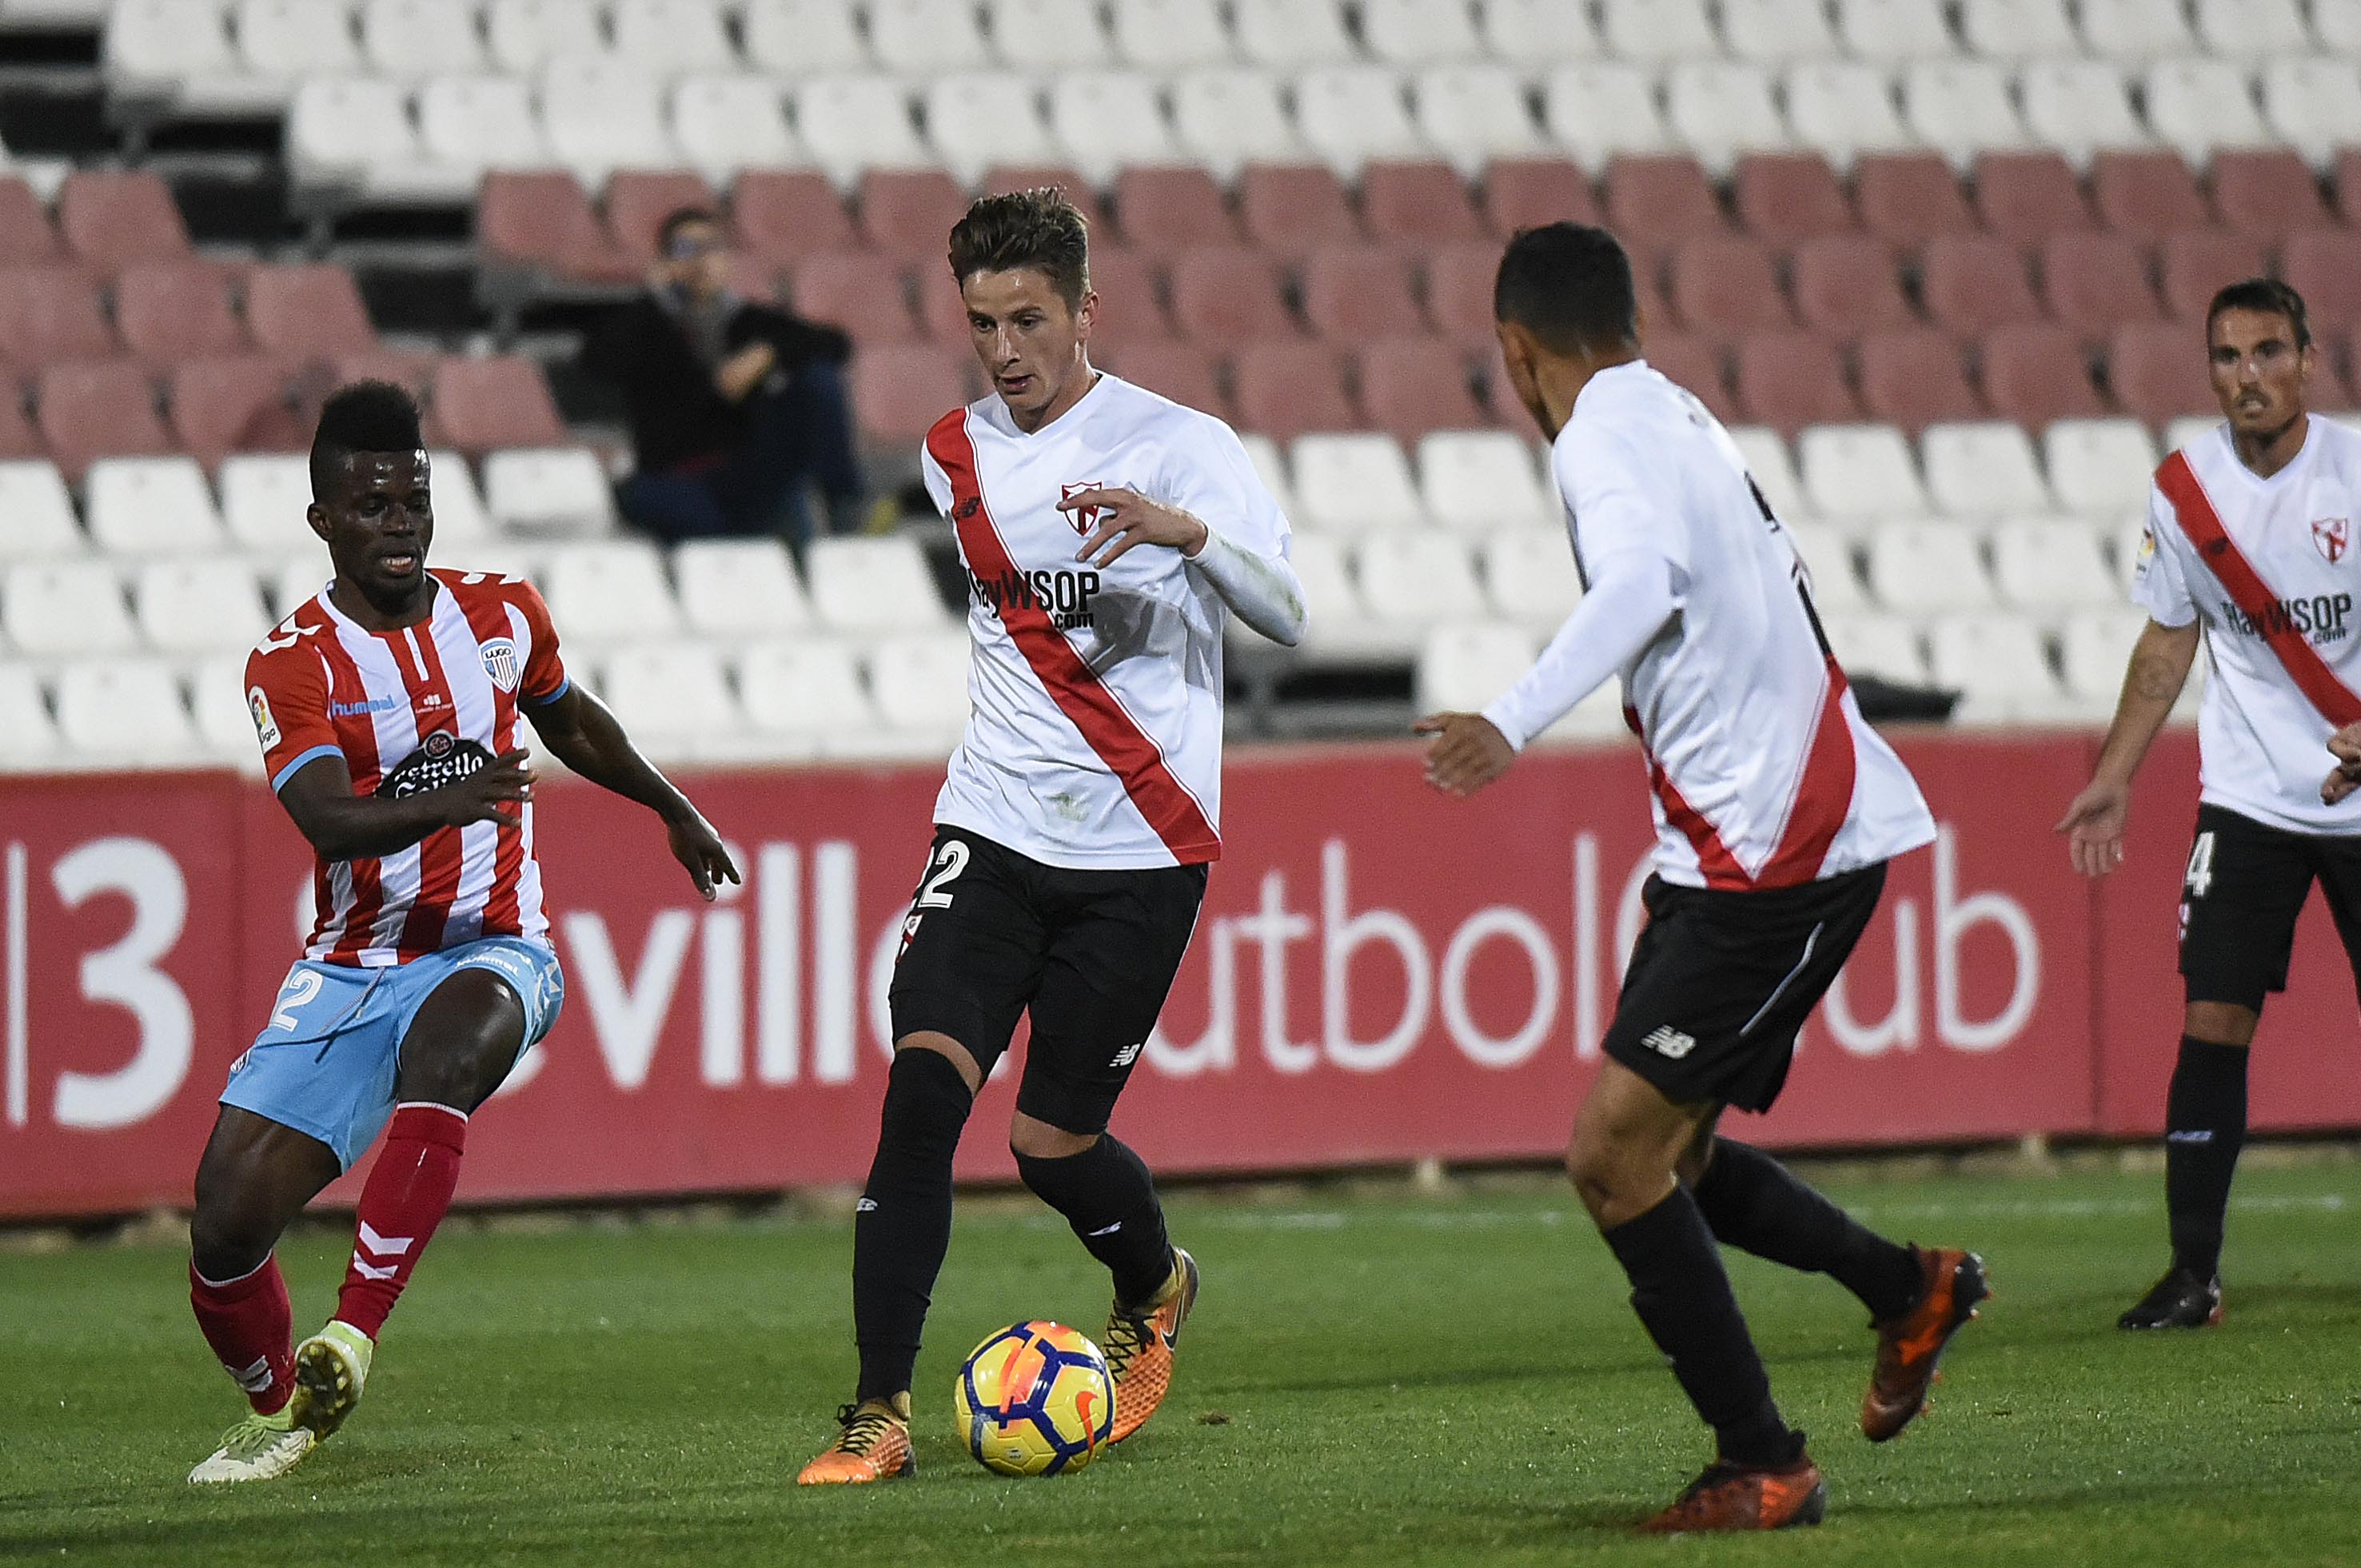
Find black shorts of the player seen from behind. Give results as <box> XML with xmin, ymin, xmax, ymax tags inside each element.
<box><xmin>1605</xmin><ymin>864</ymin><xmax>1886</xmax><ymax>1110</ymax></box>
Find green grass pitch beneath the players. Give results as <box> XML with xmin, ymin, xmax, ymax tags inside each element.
<box><xmin>0</xmin><ymin>1162</ymin><xmax>2361</xmax><ymax>1568</ymax></box>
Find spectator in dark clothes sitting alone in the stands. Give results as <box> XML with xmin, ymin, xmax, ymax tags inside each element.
<box><xmin>585</xmin><ymin>208</ymin><xmax>864</xmax><ymax>550</ymax></box>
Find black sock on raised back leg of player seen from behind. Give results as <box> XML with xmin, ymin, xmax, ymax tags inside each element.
<box><xmin>1693</xmin><ymin>1138</ymin><xmax>1927</xmax><ymax>1320</ymax></box>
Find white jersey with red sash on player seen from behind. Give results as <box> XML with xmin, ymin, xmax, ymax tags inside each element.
<box><xmin>1551</xmin><ymin>361</ymin><xmax>1934</xmax><ymax>888</ymax></box>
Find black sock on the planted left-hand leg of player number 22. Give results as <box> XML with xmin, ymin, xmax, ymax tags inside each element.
<box><xmin>852</xmin><ymin>1051</ymin><xmax>975</xmax><ymax>1400</ymax></box>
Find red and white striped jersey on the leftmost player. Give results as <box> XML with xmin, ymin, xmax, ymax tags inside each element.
<box><xmin>245</xmin><ymin>572</ymin><xmax>567</xmax><ymax>968</ymax></box>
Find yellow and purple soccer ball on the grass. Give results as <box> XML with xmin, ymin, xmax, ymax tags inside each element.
<box><xmin>951</xmin><ymin>1323</ymin><xmax>1115</xmax><ymax>1476</ymax></box>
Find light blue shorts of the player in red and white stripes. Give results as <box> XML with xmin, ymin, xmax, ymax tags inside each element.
<box><xmin>222</xmin><ymin>937</ymin><xmax>567</xmax><ymax>1171</ymax></box>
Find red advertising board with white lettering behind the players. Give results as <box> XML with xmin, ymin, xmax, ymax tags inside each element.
<box><xmin>14</xmin><ymin>734</ymin><xmax>2361</xmax><ymax>1216</ymax></box>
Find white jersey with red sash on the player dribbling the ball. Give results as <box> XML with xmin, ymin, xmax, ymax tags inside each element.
<box><xmin>921</xmin><ymin>373</ymin><xmax>1289</xmax><ymax>869</ymax></box>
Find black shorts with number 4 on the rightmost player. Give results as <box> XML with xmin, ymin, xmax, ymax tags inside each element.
<box><xmin>2182</xmin><ymin>805</ymin><xmax>2361</xmax><ymax>1011</ymax></box>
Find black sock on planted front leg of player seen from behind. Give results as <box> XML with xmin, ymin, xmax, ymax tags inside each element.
<box><xmin>1601</xmin><ymin>1186</ymin><xmax>1804</xmax><ymax>1469</ymax></box>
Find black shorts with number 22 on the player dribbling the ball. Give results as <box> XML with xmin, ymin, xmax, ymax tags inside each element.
<box><xmin>887</xmin><ymin>827</ymin><xmax>1206</xmax><ymax>1134</ymax></box>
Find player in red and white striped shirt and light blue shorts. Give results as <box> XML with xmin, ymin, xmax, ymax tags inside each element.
<box><xmin>189</xmin><ymin>382</ymin><xmax>736</xmax><ymax>1483</ymax></box>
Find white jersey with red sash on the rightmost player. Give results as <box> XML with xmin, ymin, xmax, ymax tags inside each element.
<box><xmin>2132</xmin><ymin>416</ymin><xmax>2361</xmax><ymax>834</ymax></box>
